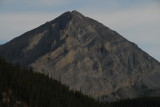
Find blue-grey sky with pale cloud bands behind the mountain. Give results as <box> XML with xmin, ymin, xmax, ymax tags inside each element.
<box><xmin>0</xmin><ymin>0</ymin><xmax>160</xmax><ymax>61</ymax></box>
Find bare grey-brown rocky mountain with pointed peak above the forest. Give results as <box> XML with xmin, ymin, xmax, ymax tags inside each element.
<box><xmin>0</xmin><ymin>11</ymin><xmax>160</xmax><ymax>101</ymax></box>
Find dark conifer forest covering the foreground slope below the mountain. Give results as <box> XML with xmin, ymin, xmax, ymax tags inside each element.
<box><xmin>0</xmin><ymin>58</ymin><xmax>160</xmax><ymax>107</ymax></box>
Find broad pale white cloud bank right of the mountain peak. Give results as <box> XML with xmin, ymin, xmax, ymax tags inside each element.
<box><xmin>81</xmin><ymin>4</ymin><xmax>160</xmax><ymax>41</ymax></box>
